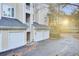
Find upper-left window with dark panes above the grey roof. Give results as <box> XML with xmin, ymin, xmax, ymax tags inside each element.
<box><xmin>2</xmin><ymin>5</ymin><xmax>14</xmax><ymax>17</ymax></box>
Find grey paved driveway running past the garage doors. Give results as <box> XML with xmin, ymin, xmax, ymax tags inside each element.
<box><xmin>0</xmin><ymin>36</ymin><xmax>79</xmax><ymax>56</ymax></box>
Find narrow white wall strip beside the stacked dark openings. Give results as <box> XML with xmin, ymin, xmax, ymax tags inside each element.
<box><xmin>25</xmin><ymin>3</ymin><xmax>34</xmax><ymax>42</ymax></box>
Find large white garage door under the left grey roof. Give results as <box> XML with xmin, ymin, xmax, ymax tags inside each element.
<box><xmin>8</xmin><ymin>32</ymin><xmax>25</xmax><ymax>48</ymax></box>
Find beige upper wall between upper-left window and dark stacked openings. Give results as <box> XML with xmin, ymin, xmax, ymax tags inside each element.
<box><xmin>16</xmin><ymin>3</ymin><xmax>26</xmax><ymax>24</ymax></box>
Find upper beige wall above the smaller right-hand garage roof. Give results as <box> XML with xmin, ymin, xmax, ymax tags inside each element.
<box><xmin>34</xmin><ymin>3</ymin><xmax>48</xmax><ymax>25</ymax></box>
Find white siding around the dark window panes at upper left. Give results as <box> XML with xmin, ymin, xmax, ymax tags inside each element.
<box><xmin>1</xmin><ymin>3</ymin><xmax>16</xmax><ymax>18</ymax></box>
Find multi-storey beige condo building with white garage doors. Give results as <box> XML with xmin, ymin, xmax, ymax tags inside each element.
<box><xmin>0</xmin><ymin>3</ymin><xmax>49</xmax><ymax>52</ymax></box>
